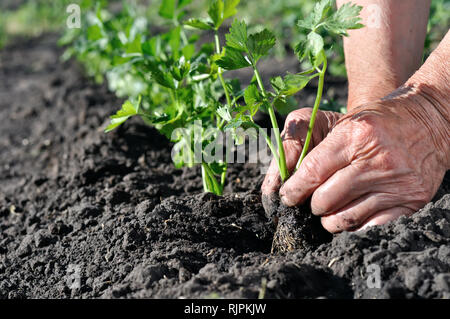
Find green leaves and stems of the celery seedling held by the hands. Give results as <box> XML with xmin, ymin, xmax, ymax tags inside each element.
<box><xmin>217</xmin><ymin>0</ymin><xmax>363</xmax><ymax>182</ymax></box>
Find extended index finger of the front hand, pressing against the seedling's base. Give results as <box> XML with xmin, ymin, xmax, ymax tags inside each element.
<box><xmin>280</xmin><ymin>131</ymin><xmax>351</xmax><ymax>206</ymax></box>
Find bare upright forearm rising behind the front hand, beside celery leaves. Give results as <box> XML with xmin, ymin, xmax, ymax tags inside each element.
<box><xmin>337</xmin><ymin>0</ymin><xmax>430</xmax><ymax>110</ymax></box>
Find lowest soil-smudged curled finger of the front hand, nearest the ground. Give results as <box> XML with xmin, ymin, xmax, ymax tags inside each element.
<box><xmin>321</xmin><ymin>193</ymin><xmax>398</xmax><ymax>233</ymax></box>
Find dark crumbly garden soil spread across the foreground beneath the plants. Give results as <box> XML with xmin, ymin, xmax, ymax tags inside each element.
<box><xmin>0</xmin><ymin>36</ymin><xmax>450</xmax><ymax>298</ymax></box>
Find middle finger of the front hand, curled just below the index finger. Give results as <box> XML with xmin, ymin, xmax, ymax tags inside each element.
<box><xmin>311</xmin><ymin>165</ymin><xmax>373</xmax><ymax>216</ymax></box>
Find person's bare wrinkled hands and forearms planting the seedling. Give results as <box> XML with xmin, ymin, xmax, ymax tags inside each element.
<box><xmin>262</xmin><ymin>0</ymin><xmax>450</xmax><ymax>232</ymax></box>
